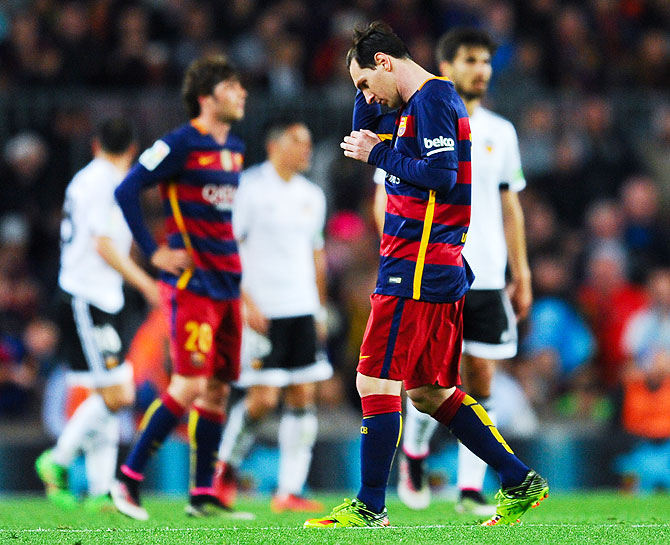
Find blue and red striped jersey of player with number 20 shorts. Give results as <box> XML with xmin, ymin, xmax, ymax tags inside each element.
<box><xmin>115</xmin><ymin>121</ymin><xmax>244</xmax><ymax>300</ymax></box>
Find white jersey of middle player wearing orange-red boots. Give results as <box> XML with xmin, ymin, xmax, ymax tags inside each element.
<box><xmin>233</xmin><ymin>161</ymin><xmax>326</xmax><ymax>318</ymax></box>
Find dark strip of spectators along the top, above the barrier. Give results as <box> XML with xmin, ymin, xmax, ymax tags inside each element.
<box><xmin>0</xmin><ymin>0</ymin><xmax>670</xmax><ymax>96</ymax></box>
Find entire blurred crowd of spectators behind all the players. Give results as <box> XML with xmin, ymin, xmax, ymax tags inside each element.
<box><xmin>0</xmin><ymin>0</ymin><xmax>670</xmax><ymax>484</ymax></box>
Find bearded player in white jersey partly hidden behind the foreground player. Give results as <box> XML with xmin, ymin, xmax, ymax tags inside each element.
<box><xmin>375</xmin><ymin>28</ymin><xmax>532</xmax><ymax>516</ymax></box>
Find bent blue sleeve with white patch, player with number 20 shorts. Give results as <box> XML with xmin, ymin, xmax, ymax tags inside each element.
<box><xmin>114</xmin><ymin>133</ymin><xmax>188</xmax><ymax>257</ymax></box>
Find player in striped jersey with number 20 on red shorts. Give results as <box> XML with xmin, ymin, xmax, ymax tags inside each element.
<box><xmin>112</xmin><ymin>57</ymin><xmax>247</xmax><ymax>520</ymax></box>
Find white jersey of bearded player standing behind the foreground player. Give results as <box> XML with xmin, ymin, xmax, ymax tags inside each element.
<box><xmin>463</xmin><ymin>107</ymin><xmax>526</xmax><ymax>290</ymax></box>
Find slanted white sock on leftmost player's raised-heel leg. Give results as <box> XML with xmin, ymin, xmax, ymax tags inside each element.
<box><xmin>52</xmin><ymin>393</ymin><xmax>110</xmax><ymax>467</ymax></box>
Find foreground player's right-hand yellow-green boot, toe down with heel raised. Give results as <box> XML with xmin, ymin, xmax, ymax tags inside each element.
<box><xmin>482</xmin><ymin>470</ymin><xmax>549</xmax><ymax>526</ymax></box>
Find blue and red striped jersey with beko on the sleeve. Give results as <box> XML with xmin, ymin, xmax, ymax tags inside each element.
<box><xmin>354</xmin><ymin>78</ymin><xmax>474</xmax><ymax>303</ymax></box>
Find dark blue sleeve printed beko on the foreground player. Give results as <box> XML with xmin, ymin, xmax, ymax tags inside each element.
<box><xmin>368</xmin><ymin>95</ymin><xmax>462</xmax><ymax>193</ymax></box>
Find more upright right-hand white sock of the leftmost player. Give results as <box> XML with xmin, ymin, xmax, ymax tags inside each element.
<box><xmin>84</xmin><ymin>413</ymin><xmax>121</xmax><ymax>497</ymax></box>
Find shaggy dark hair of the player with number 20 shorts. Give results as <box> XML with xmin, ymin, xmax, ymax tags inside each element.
<box><xmin>181</xmin><ymin>55</ymin><xmax>239</xmax><ymax>119</ymax></box>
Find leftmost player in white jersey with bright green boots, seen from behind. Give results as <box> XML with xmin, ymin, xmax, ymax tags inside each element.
<box><xmin>35</xmin><ymin>118</ymin><xmax>158</xmax><ymax>508</ymax></box>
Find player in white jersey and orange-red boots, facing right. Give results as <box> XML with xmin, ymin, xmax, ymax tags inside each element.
<box><xmin>214</xmin><ymin>120</ymin><xmax>332</xmax><ymax>512</ymax></box>
